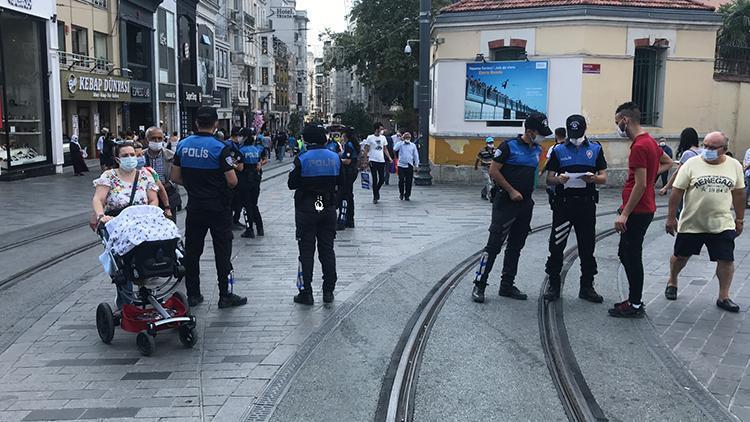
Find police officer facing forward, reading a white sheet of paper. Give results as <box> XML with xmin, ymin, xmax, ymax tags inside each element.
<box><xmin>544</xmin><ymin>115</ymin><xmax>607</xmax><ymax>303</ymax></box>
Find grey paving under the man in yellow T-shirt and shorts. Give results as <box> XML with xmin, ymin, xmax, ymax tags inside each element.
<box><xmin>644</xmin><ymin>221</ymin><xmax>750</xmax><ymax>421</ymax></box>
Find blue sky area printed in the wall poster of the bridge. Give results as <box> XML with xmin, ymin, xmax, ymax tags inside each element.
<box><xmin>466</xmin><ymin>61</ymin><xmax>549</xmax><ymax>113</ymax></box>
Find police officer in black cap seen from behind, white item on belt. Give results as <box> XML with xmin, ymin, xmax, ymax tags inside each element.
<box><xmin>288</xmin><ymin>125</ymin><xmax>344</xmax><ymax>305</ymax></box>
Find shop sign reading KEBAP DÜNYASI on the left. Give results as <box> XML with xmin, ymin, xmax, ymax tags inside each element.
<box><xmin>60</xmin><ymin>70</ymin><xmax>131</xmax><ymax>101</ymax></box>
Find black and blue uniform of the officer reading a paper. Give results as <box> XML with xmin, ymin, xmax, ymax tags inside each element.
<box><xmin>546</xmin><ymin>140</ymin><xmax>607</xmax><ymax>302</ymax></box>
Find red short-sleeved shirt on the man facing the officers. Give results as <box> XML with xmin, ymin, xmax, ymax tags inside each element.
<box><xmin>622</xmin><ymin>133</ymin><xmax>664</xmax><ymax>214</ymax></box>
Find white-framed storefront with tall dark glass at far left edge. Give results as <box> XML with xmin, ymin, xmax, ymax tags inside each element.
<box><xmin>0</xmin><ymin>2</ymin><xmax>63</xmax><ymax>179</ymax></box>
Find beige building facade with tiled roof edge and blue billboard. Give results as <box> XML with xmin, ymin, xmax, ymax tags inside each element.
<box><xmin>430</xmin><ymin>0</ymin><xmax>750</xmax><ymax>183</ymax></box>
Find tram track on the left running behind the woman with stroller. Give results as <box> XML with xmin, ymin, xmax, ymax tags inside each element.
<box><xmin>0</xmin><ymin>163</ymin><xmax>288</xmax><ymax>291</ymax></box>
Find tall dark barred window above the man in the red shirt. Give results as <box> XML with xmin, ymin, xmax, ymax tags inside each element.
<box><xmin>633</xmin><ymin>47</ymin><xmax>667</xmax><ymax>126</ymax></box>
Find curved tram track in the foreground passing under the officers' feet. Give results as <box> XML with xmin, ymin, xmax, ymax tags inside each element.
<box><xmin>384</xmin><ymin>207</ymin><xmax>666</xmax><ymax>422</ymax></box>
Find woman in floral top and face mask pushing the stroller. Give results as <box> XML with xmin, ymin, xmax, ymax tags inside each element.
<box><xmin>92</xmin><ymin>142</ymin><xmax>159</xmax><ymax>228</ymax></box>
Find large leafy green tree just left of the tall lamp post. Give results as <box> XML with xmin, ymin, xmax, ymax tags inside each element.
<box><xmin>325</xmin><ymin>0</ymin><xmax>450</xmax><ymax>108</ymax></box>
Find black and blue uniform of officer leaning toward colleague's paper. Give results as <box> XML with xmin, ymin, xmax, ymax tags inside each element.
<box><xmin>474</xmin><ymin>138</ymin><xmax>542</xmax><ymax>301</ymax></box>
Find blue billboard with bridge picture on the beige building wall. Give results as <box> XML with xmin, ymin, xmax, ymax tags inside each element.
<box><xmin>464</xmin><ymin>60</ymin><xmax>549</xmax><ymax>121</ymax></box>
